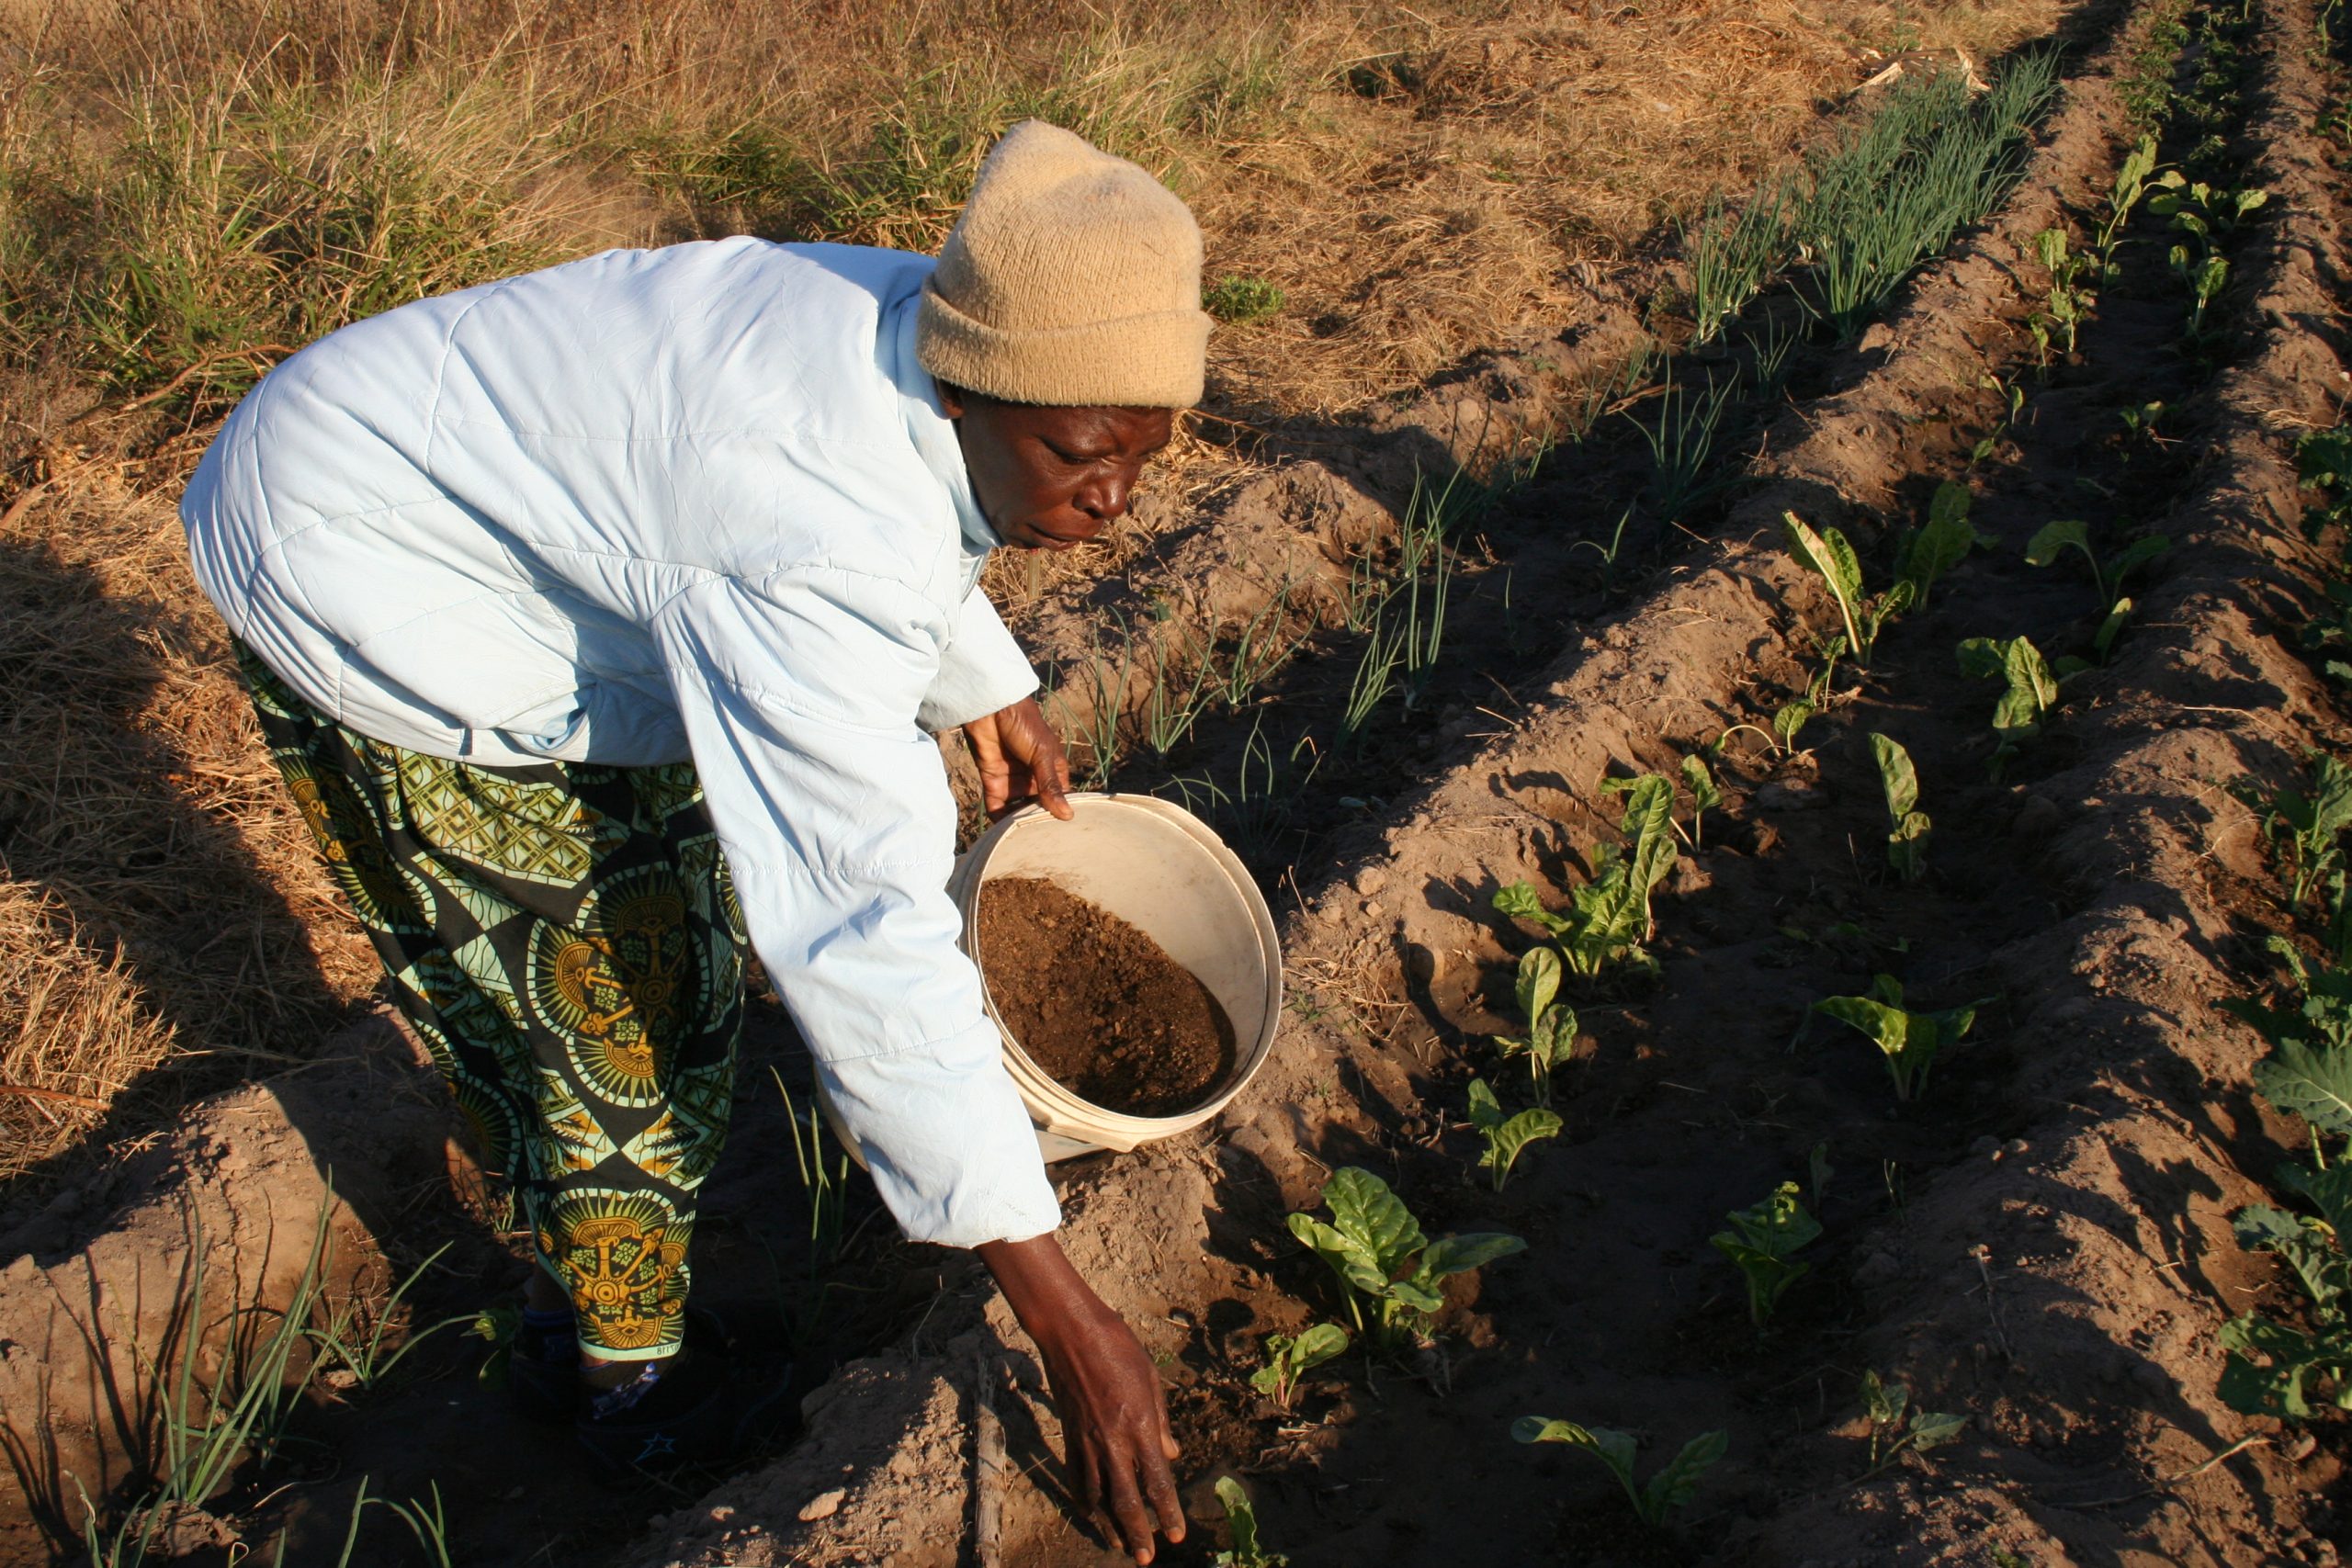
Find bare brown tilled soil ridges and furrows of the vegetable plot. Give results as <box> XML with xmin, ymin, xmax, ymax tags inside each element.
<box><xmin>0</xmin><ymin>0</ymin><xmax>2352</xmax><ymax>1568</ymax></box>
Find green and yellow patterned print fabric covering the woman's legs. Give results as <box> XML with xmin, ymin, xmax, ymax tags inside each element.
<box><xmin>238</xmin><ymin>647</ymin><xmax>743</xmax><ymax>1361</ymax></box>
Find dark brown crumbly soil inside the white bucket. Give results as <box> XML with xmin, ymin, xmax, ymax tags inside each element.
<box><xmin>978</xmin><ymin>877</ymin><xmax>1232</xmax><ymax>1117</ymax></box>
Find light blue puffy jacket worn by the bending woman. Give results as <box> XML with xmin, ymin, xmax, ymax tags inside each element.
<box><xmin>181</xmin><ymin>240</ymin><xmax>1061</xmax><ymax>1246</ymax></box>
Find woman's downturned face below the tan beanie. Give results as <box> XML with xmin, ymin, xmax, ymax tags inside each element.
<box><xmin>938</xmin><ymin>383</ymin><xmax>1173</xmax><ymax>550</ymax></box>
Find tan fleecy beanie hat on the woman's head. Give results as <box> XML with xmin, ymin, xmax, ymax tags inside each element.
<box><xmin>915</xmin><ymin>120</ymin><xmax>1209</xmax><ymax>409</ymax></box>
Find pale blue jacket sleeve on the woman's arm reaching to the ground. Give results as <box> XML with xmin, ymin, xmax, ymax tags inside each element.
<box><xmin>654</xmin><ymin>567</ymin><xmax>1061</xmax><ymax>1246</ymax></box>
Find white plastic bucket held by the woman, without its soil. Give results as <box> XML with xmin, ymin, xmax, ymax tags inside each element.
<box><xmin>819</xmin><ymin>795</ymin><xmax>1282</xmax><ymax>1164</ymax></box>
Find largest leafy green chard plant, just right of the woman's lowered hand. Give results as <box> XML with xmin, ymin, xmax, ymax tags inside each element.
<box><xmin>1289</xmin><ymin>1166</ymin><xmax>1526</xmax><ymax>1349</ymax></box>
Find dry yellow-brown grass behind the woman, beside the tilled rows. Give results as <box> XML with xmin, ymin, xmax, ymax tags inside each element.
<box><xmin>0</xmin><ymin>0</ymin><xmax>2055</xmax><ymax>1176</ymax></box>
